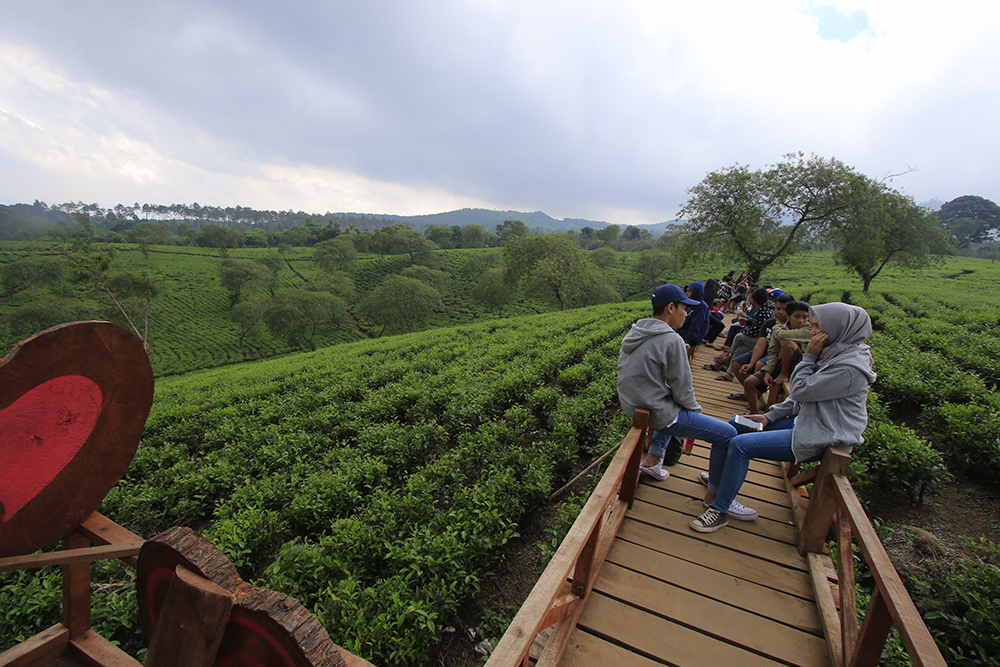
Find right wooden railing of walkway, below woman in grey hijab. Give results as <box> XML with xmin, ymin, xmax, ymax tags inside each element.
<box><xmin>786</xmin><ymin>447</ymin><xmax>947</xmax><ymax>667</ymax></box>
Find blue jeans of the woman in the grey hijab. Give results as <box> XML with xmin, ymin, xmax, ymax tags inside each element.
<box><xmin>708</xmin><ymin>417</ymin><xmax>795</xmax><ymax>512</ymax></box>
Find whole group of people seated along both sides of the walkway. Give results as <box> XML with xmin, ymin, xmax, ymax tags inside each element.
<box><xmin>618</xmin><ymin>280</ymin><xmax>876</xmax><ymax>533</ymax></box>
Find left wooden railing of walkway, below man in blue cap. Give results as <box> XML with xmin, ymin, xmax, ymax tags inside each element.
<box><xmin>486</xmin><ymin>410</ymin><xmax>650</xmax><ymax>667</ymax></box>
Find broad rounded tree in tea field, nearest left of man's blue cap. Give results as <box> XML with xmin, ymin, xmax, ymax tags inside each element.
<box><xmin>504</xmin><ymin>234</ymin><xmax>619</xmax><ymax>310</ymax></box>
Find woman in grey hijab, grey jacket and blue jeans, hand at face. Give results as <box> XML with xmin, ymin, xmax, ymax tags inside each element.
<box><xmin>691</xmin><ymin>303</ymin><xmax>875</xmax><ymax>533</ymax></box>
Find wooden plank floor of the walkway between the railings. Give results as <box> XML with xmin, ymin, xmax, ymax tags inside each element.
<box><xmin>561</xmin><ymin>336</ymin><xmax>830</xmax><ymax>667</ymax></box>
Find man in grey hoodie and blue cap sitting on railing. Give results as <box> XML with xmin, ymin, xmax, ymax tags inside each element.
<box><xmin>618</xmin><ymin>285</ymin><xmax>757</xmax><ymax>521</ymax></box>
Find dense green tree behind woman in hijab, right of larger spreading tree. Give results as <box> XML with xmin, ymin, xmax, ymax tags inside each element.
<box><xmin>830</xmin><ymin>176</ymin><xmax>951</xmax><ymax>292</ymax></box>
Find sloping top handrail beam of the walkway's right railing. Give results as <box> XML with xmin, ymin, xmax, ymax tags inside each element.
<box><xmin>834</xmin><ymin>475</ymin><xmax>946</xmax><ymax>667</ymax></box>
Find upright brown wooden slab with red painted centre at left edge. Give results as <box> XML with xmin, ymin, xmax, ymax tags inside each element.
<box><xmin>0</xmin><ymin>322</ymin><xmax>153</xmax><ymax>557</ymax></box>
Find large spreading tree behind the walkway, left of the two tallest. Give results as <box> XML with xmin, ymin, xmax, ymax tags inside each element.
<box><xmin>674</xmin><ymin>153</ymin><xmax>858</xmax><ymax>281</ymax></box>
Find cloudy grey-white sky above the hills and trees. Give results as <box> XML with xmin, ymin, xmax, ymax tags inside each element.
<box><xmin>0</xmin><ymin>0</ymin><xmax>1000</xmax><ymax>224</ymax></box>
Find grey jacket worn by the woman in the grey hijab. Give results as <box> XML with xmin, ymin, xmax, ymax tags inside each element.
<box><xmin>764</xmin><ymin>347</ymin><xmax>876</xmax><ymax>462</ymax></box>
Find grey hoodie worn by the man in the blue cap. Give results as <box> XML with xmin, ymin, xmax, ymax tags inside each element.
<box><xmin>618</xmin><ymin>318</ymin><xmax>701</xmax><ymax>430</ymax></box>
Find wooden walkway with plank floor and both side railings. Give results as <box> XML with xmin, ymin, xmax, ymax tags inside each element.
<box><xmin>487</xmin><ymin>347</ymin><xmax>945</xmax><ymax>667</ymax></box>
